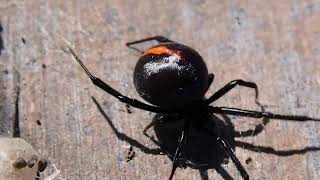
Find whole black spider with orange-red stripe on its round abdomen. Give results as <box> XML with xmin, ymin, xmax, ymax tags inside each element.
<box><xmin>69</xmin><ymin>36</ymin><xmax>320</xmax><ymax>180</ymax></box>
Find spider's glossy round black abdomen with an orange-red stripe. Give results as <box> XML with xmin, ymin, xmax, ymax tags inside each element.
<box><xmin>134</xmin><ymin>42</ymin><xmax>208</xmax><ymax>107</ymax></box>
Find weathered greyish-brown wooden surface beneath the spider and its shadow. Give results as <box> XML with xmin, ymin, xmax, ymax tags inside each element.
<box><xmin>0</xmin><ymin>0</ymin><xmax>320</xmax><ymax>179</ymax></box>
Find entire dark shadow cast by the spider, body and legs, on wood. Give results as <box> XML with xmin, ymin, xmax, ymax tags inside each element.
<box><xmin>92</xmin><ymin>97</ymin><xmax>320</xmax><ymax>180</ymax></box>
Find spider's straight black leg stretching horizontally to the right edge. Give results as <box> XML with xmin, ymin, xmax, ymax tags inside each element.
<box><xmin>208</xmin><ymin>106</ymin><xmax>320</xmax><ymax>121</ymax></box>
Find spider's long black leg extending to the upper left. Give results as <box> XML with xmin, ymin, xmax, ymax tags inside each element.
<box><xmin>69</xmin><ymin>48</ymin><xmax>176</xmax><ymax>114</ymax></box>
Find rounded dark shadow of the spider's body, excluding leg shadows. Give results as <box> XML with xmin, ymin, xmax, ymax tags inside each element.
<box><xmin>153</xmin><ymin>114</ymin><xmax>235</xmax><ymax>180</ymax></box>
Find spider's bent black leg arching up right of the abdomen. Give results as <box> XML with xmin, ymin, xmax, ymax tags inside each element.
<box><xmin>206</xmin><ymin>79</ymin><xmax>261</xmax><ymax>106</ymax></box>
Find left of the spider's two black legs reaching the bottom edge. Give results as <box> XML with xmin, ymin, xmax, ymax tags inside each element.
<box><xmin>169</xmin><ymin>121</ymin><xmax>190</xmax><ymax>180</ymax></box>
